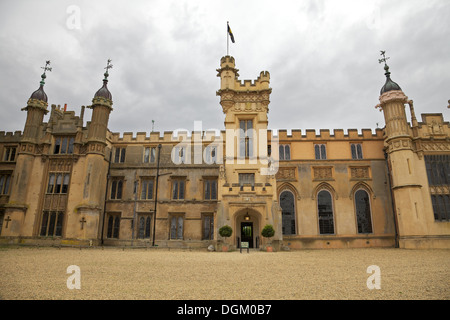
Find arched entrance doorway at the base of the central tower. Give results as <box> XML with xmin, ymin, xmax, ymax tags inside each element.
<box><xmin>235</xmin><ymin>208</ymin><xmax>261</xmax><ymax>248</ymax></box>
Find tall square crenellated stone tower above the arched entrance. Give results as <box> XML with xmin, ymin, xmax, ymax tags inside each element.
<box><xmin>217</xmin><ymin>56</ymin><xmax>282</xmax><ymax>248</ymax></box>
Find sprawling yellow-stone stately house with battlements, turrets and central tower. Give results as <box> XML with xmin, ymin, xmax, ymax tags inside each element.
<box><xmin>0</xmin><ymin>56</ymin><xmax>450</xmax><ymax>250</ymax></box>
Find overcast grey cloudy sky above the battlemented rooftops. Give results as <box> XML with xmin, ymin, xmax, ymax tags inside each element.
<box><xmin>0</xmin><ymin>0</ymin><xmax>450</xmax><ymax>133</ymax></box>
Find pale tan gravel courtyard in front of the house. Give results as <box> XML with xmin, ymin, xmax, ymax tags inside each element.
<box><xmin>0</xmin><ymin>247</ymin><xmax>450</xmax><ymax>300</ymax></box>
